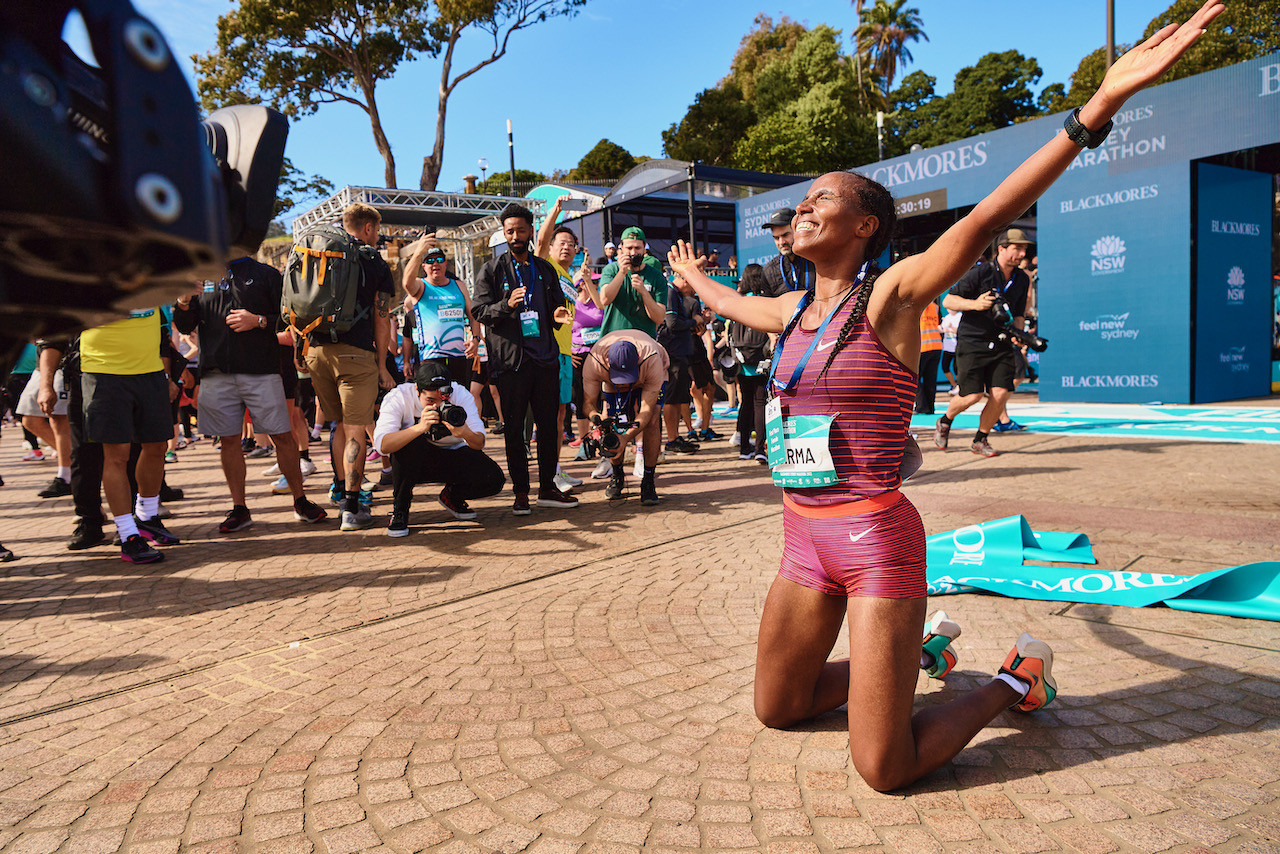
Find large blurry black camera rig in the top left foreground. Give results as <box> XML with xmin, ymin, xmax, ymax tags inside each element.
<box><xmin>0</xmin><ymin>0</ymin><xmax>288</xmax><ymax>361</ymax></box>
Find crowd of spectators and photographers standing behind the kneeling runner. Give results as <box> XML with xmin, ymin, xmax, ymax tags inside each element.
<box><xmin>0</xmin><ymin>201</ymin><xmax>1034</xmax><ymax>563</ymax></box>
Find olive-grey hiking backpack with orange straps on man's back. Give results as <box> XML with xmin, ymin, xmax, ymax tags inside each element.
<box><xmin>280</xmin><ymin>224</ymin><xmax>376</xmax><ymax>343</ymax></box>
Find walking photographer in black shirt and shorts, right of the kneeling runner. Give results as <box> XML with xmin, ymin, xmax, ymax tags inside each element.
<box><xmin>933</xmin><ymin>228</ymin><xmax>1032</xmax><ymax>457</ymax></box>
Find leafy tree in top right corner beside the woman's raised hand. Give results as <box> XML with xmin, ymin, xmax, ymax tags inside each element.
<box><xmin>1142</xmin><ymin>0</ymin><xmax>1280</xmax><ymax>83</ymax></box>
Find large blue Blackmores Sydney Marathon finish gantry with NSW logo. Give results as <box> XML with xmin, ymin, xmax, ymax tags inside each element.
<box><xmin>737</xmin><ymin>54</ymin><xmax>1280</xmax><ymax>403</ymax></box>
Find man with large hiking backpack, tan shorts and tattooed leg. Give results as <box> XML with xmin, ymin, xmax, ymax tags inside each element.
<box><xmin>280</xmin><ymin>202</ymin><xmax>396</xmax><ymax>531</ymax></box>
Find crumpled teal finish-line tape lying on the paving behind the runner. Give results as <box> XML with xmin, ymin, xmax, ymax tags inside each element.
<box><xmin>925</xmin><ymin>516</ymin><xmax>1280</xmax><ymax>621</ymax></box>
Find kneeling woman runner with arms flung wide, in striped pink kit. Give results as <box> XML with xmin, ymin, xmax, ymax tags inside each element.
<box><xmin>668</xmin><ymin>0</ymin><xmax>1222</xmax><ymax>790</ymax></box>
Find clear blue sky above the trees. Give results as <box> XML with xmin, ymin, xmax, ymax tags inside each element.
<box><xmin>122</xmin><ymin>0</ymin><xmax>1169</xmax><ymax>213</ymax></box>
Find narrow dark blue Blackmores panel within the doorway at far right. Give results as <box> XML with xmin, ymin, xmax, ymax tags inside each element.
<box><xmin>1194</xmin><ymin>163</ymin><xmax>1274</xmax><ymax>403</ymax></box>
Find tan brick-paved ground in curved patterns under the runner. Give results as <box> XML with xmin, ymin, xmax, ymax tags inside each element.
<box><xmin>0</xmin><ymin>409</ymin><xmax>1280</xmax><ymax>854</ymax></box>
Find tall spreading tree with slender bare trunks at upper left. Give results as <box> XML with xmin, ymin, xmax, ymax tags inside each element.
<box><xmin>192</xmin><ymin>0</ymin><xmax>585</xmax><ymax>188</ymax></box>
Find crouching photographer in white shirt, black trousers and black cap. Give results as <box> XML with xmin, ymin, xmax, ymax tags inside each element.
<box><xmin>374</xmin><ymin>359</ymin><xmax>507</xmax><ymax>536</ymax></box>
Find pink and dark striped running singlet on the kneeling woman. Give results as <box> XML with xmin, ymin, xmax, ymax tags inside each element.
<box><xmin>774</xmin><ymin>297</ymin><xmax>916</xmax><ymax>506</ymax></box>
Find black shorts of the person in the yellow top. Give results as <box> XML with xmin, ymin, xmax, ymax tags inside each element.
<box><xmin>81</xmin><ymin>371</ymin><xmax>173</xmax><ymax>444</ymax></box>
